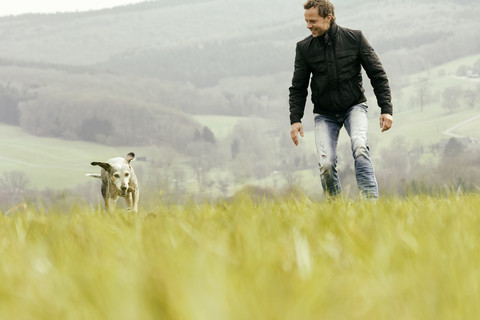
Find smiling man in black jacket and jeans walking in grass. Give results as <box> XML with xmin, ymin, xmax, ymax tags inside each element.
<box><xmin>289</xmin><ymin>0</ymin><xmax>393</xmax><ymax>198</ymax></box>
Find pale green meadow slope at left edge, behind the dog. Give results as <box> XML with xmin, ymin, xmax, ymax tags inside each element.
<box><xmin>0</xmin><ymin>125</ymin><xmax>158</xmax><ymax>189</ymax></box>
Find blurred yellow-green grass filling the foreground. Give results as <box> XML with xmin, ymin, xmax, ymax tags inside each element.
<box><xmin>0</xmin><ymin>195</ymin><xmax>480</xmax><ymax>320</ymax></box>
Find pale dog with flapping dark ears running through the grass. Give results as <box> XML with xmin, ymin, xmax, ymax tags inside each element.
<box><xmin>87</xmin><ymin>152</ymin><xmax>140</xmax><ymax>213</ymax></box>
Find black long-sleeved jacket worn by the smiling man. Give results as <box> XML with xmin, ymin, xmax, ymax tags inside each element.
<box><xmin>289</xmin><ymin>22</ymin><xmax>393</xmax><ymax>123</ymax></box>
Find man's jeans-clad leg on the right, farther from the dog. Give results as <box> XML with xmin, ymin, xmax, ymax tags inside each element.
<box><xmin>345</xmin><ymin>104</ymin><xmax>378</xmax><ymax>198</ymax></box>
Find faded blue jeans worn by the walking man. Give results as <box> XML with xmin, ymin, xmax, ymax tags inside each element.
<box><xmin>315</xmin><ymin>104</ymin><xmax>378</xmax><ymax>198</ymax></box>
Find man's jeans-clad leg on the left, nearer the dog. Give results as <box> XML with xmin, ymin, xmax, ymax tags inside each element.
<box><xmin>315</xmin><ymin>115</ymin><xmax>342</xmax><ymax>197</ymax></box>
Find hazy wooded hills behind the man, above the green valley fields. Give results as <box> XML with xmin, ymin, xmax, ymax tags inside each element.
<box><xmin>0</xmin><ymin>0</ymin><xmax>480</xmax><ymax>149</ymax></box>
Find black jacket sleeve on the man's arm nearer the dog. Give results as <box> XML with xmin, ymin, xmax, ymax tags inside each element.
<box><xmin>289</xmin><ymin>43</ymin><xmax>311</xmax><ymax>124</ymax></box>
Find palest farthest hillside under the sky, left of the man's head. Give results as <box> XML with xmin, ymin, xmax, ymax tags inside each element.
<box><xmin>0</xmin><ymin>0</ymin><xmax>301</xmax><ymax>65</ymax></box>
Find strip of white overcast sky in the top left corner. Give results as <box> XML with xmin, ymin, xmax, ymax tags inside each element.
<box><xmin>0</xmin><ymin>0</ymin><xmax>145</xmax><ymax>16</ymax></box>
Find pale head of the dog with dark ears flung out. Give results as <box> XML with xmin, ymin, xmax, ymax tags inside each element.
<box><xmin>91</xmin><ymin>152</ymin><xmax>135</xmax><ymax>197</ymax></box>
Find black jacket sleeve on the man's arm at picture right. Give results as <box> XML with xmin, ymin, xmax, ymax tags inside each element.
<box><xmin>360</xmin><ymin>32</ymin><xmax>393</xmax><ymax>114</ymax></box>
